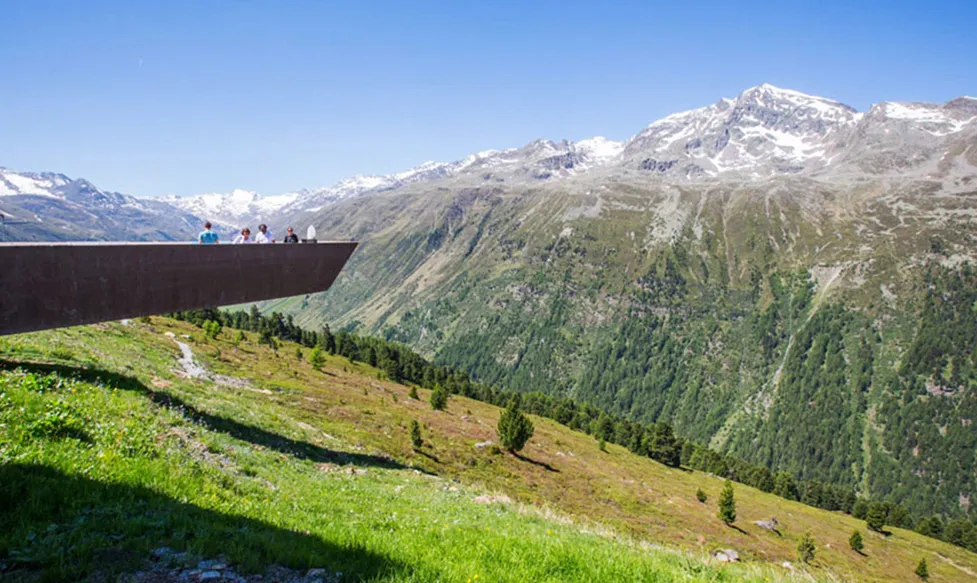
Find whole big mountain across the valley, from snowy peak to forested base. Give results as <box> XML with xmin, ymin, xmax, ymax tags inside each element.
<box><xmin>260</xmin><ymin>85</ymin><xmax>977</xmax><ymax>516</ymax></box>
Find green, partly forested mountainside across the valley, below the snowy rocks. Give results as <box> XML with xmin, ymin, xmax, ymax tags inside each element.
<box><xmin>267</xmin><ymin>178</ymin><xmax>977</xmax><ymax>521</ymax></box>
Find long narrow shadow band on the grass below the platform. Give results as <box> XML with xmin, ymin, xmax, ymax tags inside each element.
<box><xmin>0</xmin><ymin>360</ymin><xmax>406</xmax><ymax>469</ymax></box>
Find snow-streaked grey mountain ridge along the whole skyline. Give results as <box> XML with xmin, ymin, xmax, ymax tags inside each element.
<box><xmin>0</xmin><ymin>83</ymin><xmax>977</xmax><ymax>238</ymax></box>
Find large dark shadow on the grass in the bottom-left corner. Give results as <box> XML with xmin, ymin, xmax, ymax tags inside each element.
<box><xmin>0</xmin><ymin>464</ymin><xmax>409</xmax><ymax>581</ymax></box>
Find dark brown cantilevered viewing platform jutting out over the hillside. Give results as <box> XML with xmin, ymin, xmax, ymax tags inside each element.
<box><xmin>0</xmin><ymin>242</ymin><xmax>357</xmax><ymax>335</ymax></box>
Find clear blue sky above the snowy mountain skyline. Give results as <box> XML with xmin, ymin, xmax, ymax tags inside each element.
<box><xmin>0</xmin><ymin>0</ymin><xmax>977</xmax><ymax>196</ymax></box>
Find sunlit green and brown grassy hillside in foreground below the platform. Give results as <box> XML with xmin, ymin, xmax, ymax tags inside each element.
<box><xmin>0</xmin><ymin>318</ymin><xmax>977</xmax><ymax>582</ymax></box>
